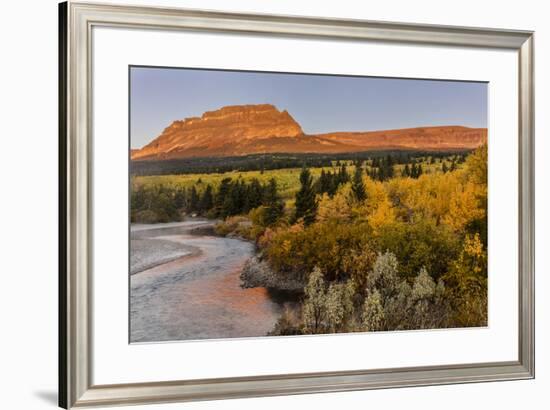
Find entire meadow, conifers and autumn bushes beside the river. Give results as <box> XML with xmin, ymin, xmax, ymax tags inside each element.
<box><xmin>131</xmin><ymin>145</ymin><xmax>487</xmax><ymax>335</ymax></box>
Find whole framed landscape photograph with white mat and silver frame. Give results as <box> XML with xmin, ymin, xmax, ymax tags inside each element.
<box><xmin>59</xmin><ymin>2</ymin><xmax>534</xmax><ymax>408</ymax></box>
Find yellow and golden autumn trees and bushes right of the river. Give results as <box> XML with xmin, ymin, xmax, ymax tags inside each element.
<box><xmin>258</xmin><ymin>146</ymin><xmax>487</xmax><ymax>333</ymax></box>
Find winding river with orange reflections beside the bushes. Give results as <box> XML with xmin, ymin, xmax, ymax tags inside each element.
<box><xmin>130</xmin><ymin>221</ymin><xmax>282</xmax><ymax>342</ymax></box>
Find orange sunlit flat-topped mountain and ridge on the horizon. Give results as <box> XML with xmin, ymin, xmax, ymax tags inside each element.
<box><xmin>130</xmin><ymin>104</ymin><xmax>487</xmax><ymax>160</ymax></box>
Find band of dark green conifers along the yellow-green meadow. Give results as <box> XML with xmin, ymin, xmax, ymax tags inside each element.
<box><xmin>131</xmin><ymin>155</ymin><xmax>465</xmax><ymax>225</ymax></box>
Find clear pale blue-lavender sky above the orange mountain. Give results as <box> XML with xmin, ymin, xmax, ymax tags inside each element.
<box><xmin>130</xmin><ymin>67</ymin><xmax>488</xmax><ymax>148</ymax></box>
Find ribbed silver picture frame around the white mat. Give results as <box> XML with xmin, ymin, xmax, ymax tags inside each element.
<box><xmin>59</xmin><ymin>2</ymin><xmax>535</xmax><ymax>408</ymax></box>
